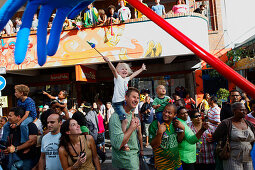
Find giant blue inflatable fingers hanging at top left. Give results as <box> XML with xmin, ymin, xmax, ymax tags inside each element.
<box><xmin>0</xmin><ymin>0</ymin><xmax>94</xmax><ymax>66</ymax></box>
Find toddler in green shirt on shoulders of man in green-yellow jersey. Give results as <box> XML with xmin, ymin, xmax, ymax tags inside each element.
<box><xmin>152</xmin><ymin>85</ymin><xmax>171</xmax><ymax>123</ymax></box>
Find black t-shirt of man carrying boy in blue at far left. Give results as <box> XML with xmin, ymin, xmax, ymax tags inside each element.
<box><xmin>9</xmin><ymin>123</ymin><xmax>38</xmax><ymax>159</ymax></box>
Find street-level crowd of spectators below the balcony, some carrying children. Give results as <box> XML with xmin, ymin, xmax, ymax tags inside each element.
<box><xmin>0</xmin><ymin>57</ymin><xmax>255</xmax><ymax>170</ymax></box>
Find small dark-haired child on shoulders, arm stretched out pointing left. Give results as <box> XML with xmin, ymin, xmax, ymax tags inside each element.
<box><xmin>43</xmin><ymin>90</ymin><xmax>69</xmax><ymax>120</ymax></box>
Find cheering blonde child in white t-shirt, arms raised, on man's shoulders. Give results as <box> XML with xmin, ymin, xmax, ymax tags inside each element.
<box><xmin>103</xmin><ymin>56</ymin><xmax>146</xmax><ymax>151</ymax></box>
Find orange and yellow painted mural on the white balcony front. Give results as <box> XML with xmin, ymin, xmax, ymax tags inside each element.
<box><xmin>0</xmin><ymin>25</ymin><xmax>162</xmax><ymax>70</ymax></box>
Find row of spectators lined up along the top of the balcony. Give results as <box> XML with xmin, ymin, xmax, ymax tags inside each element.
<box><xmin>1</xmin><ymin>0</ymin><xmax>205</xmax><ymax>36</ymax></box>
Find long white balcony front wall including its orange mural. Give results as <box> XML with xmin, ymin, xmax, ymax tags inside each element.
<box><xmin>0</xmin><ymin>13</ymin><xmax>209</xmax><ymax>71</ymax></box>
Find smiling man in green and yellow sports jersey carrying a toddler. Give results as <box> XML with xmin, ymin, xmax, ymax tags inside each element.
<box><xmin>149</xmin><ymin>104</ymin><xmax>185</xmax><ymax>170</ymax></box>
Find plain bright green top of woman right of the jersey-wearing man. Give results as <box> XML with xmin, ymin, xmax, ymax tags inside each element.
<box><xmin>178</xmin><ymin>118</ymin><xmax>199</xmax><ymax>163</ymax></box>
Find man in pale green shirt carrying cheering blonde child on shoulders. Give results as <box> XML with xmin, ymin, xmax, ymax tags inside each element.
<box><xmin>109</xmin><ymin>88</ymin><xmax>140</xmax><ymax>170</ymax></box>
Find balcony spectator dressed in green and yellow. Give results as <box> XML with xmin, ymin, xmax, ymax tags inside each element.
<box><xmin>84</xmin><ymin>3</ymin><xmax>98</xmax><ymax>28</ymax></box>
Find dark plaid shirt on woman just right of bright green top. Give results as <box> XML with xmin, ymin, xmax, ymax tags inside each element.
<box><xmin>188</xmin><ymin>123</ymin><xmax>215</xmax><ymax>164</ymax></box>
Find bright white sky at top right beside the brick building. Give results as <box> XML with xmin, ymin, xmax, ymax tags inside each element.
<box><xmin>222</xmin><ymin>0</ymin><xmax>255</xmax><ymax>46</ymax></box>
